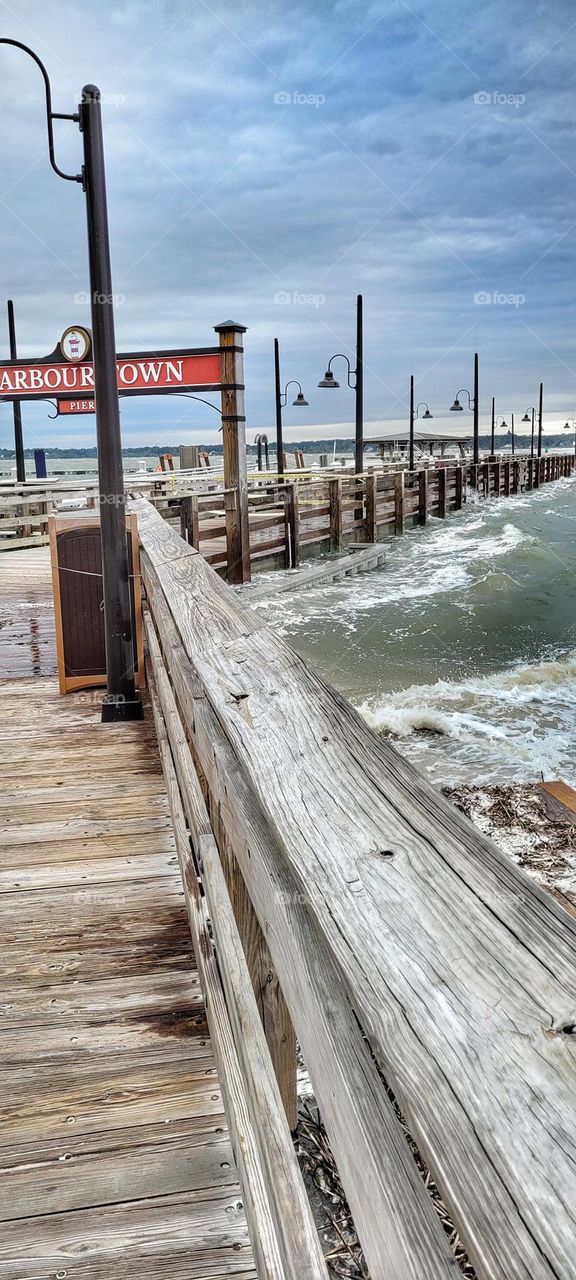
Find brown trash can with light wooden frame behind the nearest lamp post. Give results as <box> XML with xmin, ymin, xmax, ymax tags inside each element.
<box><xmin>49</xmin><ymin>511</ymin><xmax>145</xmax><ymax>694</ymax></box>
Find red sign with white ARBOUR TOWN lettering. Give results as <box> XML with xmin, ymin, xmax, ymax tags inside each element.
<box><xmin>0</xmin><ymin>351</ymin><xmax>221</xmax><ymax>399</ymax></box>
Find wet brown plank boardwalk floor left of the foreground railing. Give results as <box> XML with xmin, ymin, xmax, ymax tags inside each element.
<box><xmin>0</xmin><ymin>548</ymin><xmax>256</xmax><ymax>1280</ymax></box>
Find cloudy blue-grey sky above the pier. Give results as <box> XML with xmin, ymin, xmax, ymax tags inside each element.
<box><xmin>0</xmin><ymin>0</ymin><xmax>576</xmax><ymax>447</ymax></box>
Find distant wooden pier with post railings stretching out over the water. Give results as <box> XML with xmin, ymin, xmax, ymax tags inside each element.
<box><xmin>0</xmin><ymin>453</ymin><xmax>575</xmax><ymax>582</ymax></box>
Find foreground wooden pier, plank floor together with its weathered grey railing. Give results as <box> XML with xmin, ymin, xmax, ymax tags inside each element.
<box><xmin>0</xmin><ymin>496</ymin><xmax>576</xmax><ymax>1280</ymax></box>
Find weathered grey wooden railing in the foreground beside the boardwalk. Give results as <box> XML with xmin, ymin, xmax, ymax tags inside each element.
<box><xmin>134</xmin><ymin>499</ymin><xmax>576</xmax><ymax>1280</ymax></box>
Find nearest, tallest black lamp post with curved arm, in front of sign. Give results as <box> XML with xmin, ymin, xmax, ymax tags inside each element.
<box><xmin>0</xmin><ymin>37</ymin><xmax>142</xmax><ymax>721</ymax></box>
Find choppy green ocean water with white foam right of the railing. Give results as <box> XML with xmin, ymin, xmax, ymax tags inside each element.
<box><xmin>259</xmin><ymin>479</ymin><xmax>576</xmax><ymax>785</ymax></box>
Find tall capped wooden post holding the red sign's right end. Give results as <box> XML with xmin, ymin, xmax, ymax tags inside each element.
<box><xmin>214</xmin><ymin>320</ymin><xmax>251</xmax><ymax>582</ymax></box>
